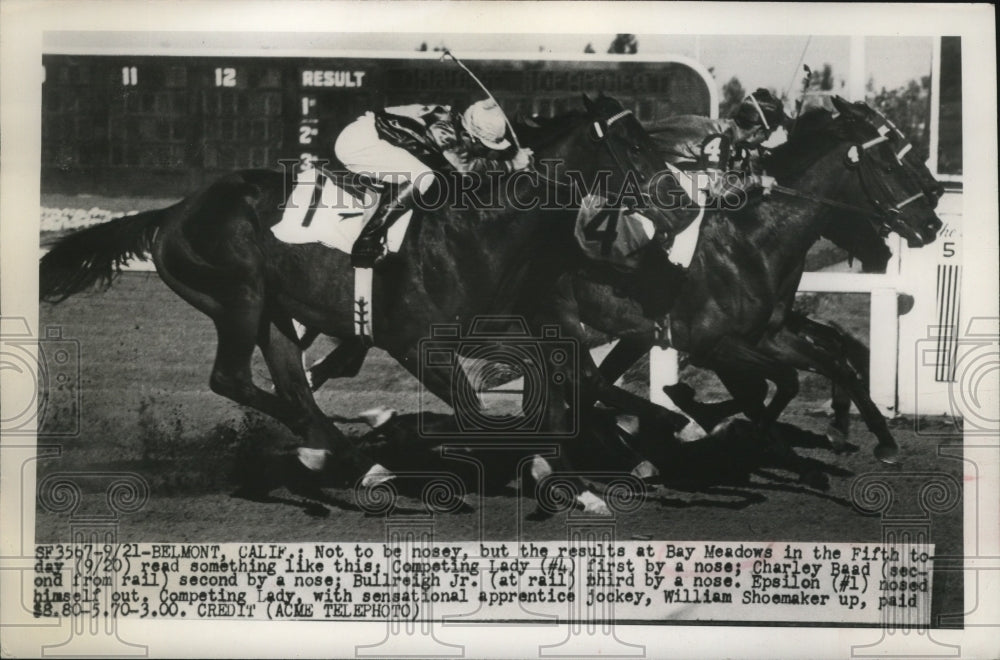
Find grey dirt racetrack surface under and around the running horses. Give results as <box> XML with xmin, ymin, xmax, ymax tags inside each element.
<box><xmin>36</xmin><ymin>272</ymin><xmax>963</xmax><ymax>628</ymax></box>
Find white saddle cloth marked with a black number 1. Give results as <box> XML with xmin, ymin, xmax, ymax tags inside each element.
<box><xmin>271</xmin><ymin>168</ymin><xmax>413</xmax><ymax>254</ymax></box>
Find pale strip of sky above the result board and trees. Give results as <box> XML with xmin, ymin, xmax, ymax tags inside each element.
<box><xmin>44</xmin><ymin>32</ymin><xmax>932</xmax><ymax>97</ymax></box>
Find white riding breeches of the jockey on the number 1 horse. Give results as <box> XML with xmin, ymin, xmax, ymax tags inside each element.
<box><xmin>333</xmin><ymin>112</ymin><xmax>434</xmax><ymax>193</ymax></box>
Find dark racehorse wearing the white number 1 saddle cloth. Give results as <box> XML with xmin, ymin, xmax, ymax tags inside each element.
<box><xmin>40</xmin><ymin>95</ymin><xmax>680</xmax><ymax>509</ymax></box>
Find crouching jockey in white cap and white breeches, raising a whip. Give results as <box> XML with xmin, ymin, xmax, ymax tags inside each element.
<box><xmin>334</xmin><ymin>99</ymin><xmax>532</xmax><ymax>268</ymax></box>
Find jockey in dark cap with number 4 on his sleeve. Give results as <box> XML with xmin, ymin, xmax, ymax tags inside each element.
<box><xmin>646</xmin><ymin>89</ymin><xmax>787</xmax><ymax>202</ymax></box>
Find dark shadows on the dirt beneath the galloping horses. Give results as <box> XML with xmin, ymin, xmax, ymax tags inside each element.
<box><xmin>230</xmin><ymin>410</ymin><xmax>854</xmax><ymax>515</ymax></box>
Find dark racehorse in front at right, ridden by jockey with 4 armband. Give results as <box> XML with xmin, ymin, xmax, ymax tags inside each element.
<box><xmin>558</xmin><ymin>99</ymin><xmax>941</xmax><ymax>462</ymax></box>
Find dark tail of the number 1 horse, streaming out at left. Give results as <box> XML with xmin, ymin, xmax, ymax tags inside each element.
<box><xmin>38</xmin><ymin>208</ymin><xmax>170</xmax><ymax>302</ymax></box>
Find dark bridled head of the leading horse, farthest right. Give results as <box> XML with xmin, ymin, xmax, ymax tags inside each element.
<box><xmin>768</xmin><ymin>98</ymin><xmax>942</xmax><ymax>247</ymax></box>
